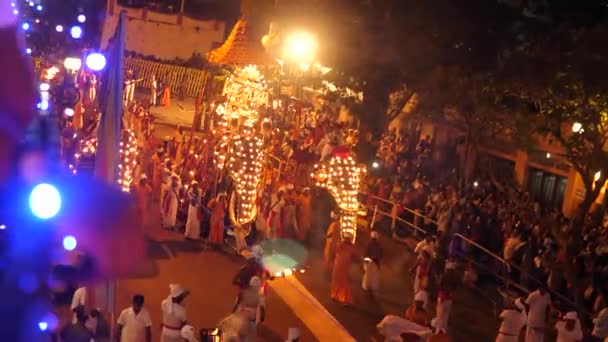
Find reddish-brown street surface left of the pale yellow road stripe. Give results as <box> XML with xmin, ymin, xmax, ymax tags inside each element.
<box><xmin>116</xmin><ymin>216</ymin><xmax>314</xmax><ymax>341</ymax></box>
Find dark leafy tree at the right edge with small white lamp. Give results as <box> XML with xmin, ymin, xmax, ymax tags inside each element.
<box><xmin>501</xmin><ymin>26</ymin><xmax>608</xmax><ymax>220</ymax></box>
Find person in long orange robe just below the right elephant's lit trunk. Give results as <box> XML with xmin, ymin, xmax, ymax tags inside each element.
<box><xmin>330</xmin><ymin>241</ymin><xmax>360</xmax><ymax>305</ymax></box>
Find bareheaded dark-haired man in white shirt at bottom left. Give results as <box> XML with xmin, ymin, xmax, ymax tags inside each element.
<box><xmin>116</xmin><ymin>294</ymin><xmax>152</xmax><ymax>342</ymax></box>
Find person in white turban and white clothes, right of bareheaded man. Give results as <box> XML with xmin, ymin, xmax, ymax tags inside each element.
<box><xmin>160</xmin><ymin>284</ymin><xmax>189</xmax><ymax>342</ymax></box>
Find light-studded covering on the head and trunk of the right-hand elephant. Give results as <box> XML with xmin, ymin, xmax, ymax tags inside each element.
<box><xmin>310</xmin><ymin>155</ymin><xmax>367</xmax><ymax>243</ymax></box>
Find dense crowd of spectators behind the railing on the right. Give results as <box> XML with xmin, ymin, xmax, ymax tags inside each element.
<box><xmin>368</xmin><ymin>129</ymin><xmax>608</xmax><ymax>341</ymax></box>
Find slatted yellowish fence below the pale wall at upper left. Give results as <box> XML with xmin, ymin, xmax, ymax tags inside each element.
<box><xmin>124</xmin><ymin>57</ymin><xmax>207</xmax><ymax>97</ymax></box>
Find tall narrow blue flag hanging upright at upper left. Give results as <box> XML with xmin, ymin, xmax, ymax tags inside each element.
<box><xmin>95</xmin><ymin>11</ymin><xmax>126</xmax><ymax>184</ymax></box>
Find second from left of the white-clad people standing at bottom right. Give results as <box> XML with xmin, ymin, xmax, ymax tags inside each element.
<box><xmin>526</xmin><ymin>287</ymin><xmax>551</xmax><ymax>342</ymax></box>
